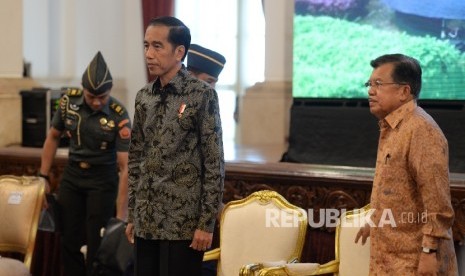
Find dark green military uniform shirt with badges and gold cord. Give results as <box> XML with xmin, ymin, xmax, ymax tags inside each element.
<box><xmin>52</xmin><ymin>94</ymin><xmax>131</xmax><ymax>165</ymax></box>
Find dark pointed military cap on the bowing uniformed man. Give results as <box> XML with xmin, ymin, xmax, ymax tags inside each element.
<box><xmin>82</xmin><ymin>51</ymin><xmax>113</xmax><ymax>95</ymax></box>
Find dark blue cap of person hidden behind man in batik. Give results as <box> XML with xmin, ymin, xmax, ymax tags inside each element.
<box><xmin>187</xmin><ymin>44</ymin><xmax>226</xmax><ymax>78</ymax></box>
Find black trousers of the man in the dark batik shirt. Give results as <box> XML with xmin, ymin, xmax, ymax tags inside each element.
<box><xmin>134</xmin><ymin>237</ymin><xmax>204</xmax><ymax>276</ymax></box>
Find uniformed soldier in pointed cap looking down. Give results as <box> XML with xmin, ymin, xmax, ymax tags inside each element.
<box><xmin>39</xmin><ymin>52</ymin><xmax>131</xmax><ymax>276</ymax></box>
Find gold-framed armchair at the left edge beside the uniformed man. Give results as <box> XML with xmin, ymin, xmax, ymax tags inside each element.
<box><xmin>0</xmin><ymin>175</ymin><xmax>45</xmax><ymax>276</ymax></box>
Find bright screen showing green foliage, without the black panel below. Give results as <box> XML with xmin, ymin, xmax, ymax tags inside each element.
<box><xmin>293</xmin><ymin>0</ymin><xmax>465</xmax><ymax>101</ymax></box>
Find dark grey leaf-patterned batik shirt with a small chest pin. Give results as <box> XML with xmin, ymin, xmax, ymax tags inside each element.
<box><xmin>128</xmin><ymin>67</ymin><xmax>224</xmax><ymax>240</ymax></box>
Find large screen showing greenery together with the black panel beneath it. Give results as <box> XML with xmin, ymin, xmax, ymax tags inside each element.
<box><xmin>282</xmin><ymin>0</ymin><xmax>465</xmax><ymax>173</ymax></box>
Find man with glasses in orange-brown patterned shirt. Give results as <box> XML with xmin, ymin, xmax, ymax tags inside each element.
<box><xmin>356</xmin><ymin>54</ymin><xmax>458</xmax><ymax>276</ymax></box>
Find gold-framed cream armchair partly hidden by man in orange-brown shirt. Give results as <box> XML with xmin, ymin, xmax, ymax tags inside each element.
<box><xmin>259</xmin><ymin>204</ymin><xmax>372</xmax><ymax>276</ymax></box>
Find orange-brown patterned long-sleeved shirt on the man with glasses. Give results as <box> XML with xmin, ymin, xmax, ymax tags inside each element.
<box><xmin>370</xmin><ymin>100</ymin><xmax>457</xmax><ymax>275</ymax></box>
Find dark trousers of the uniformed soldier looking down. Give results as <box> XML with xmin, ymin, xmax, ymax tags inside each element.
<box><xmin>58</xmin><ymin>164</ymin><xmax>118</xmax><ymax>276</ymax></box>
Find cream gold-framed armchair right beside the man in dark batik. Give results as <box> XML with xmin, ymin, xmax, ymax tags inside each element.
<box><xmin>204</xmin><ymin>190</ymin><xmax>307</xmax><ymax>276</ymax></box>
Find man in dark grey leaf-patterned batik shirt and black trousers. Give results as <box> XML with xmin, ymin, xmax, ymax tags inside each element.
<box><xmin>126</xmin><ymin>16</ymin><xmax>224</xmax><ymax>276</ymax></box>
